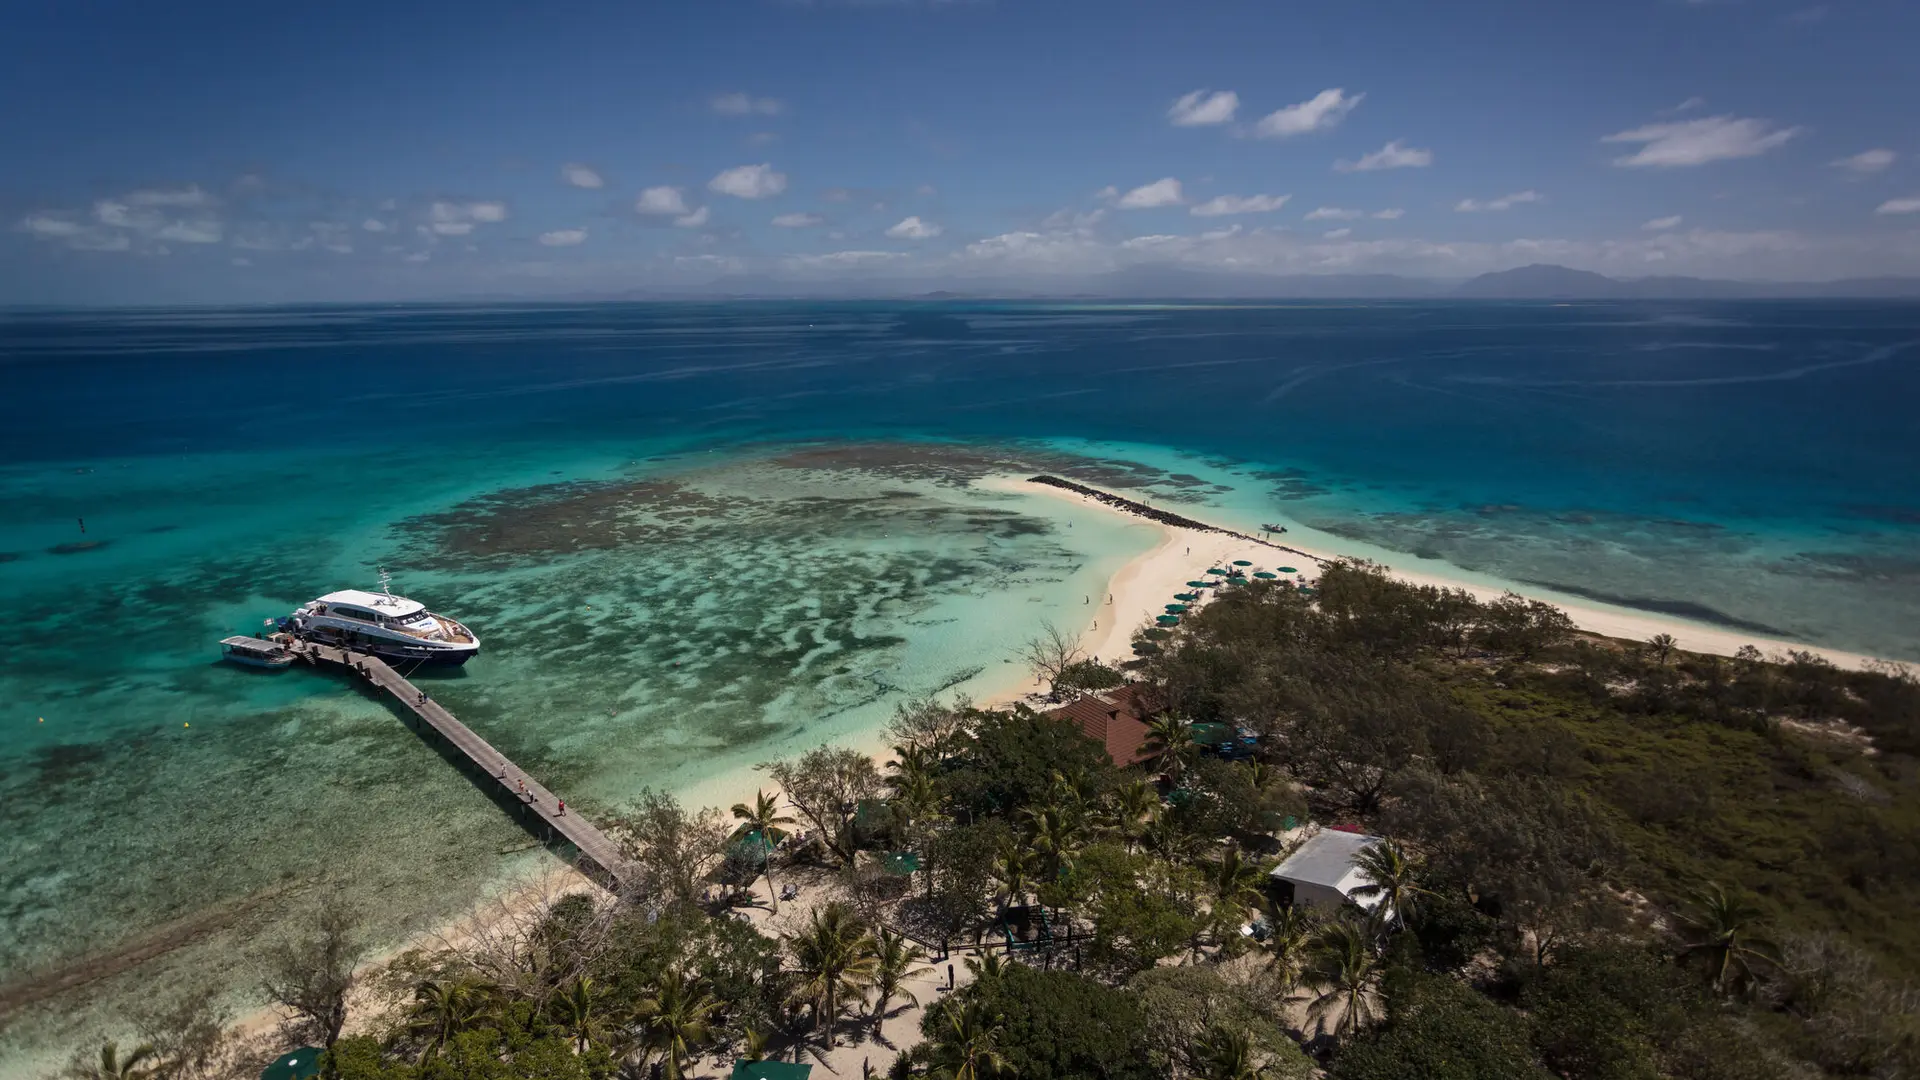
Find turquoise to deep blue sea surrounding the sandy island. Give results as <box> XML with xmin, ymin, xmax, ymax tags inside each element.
<box><xmin>0</xmin><ymin>304</ymin><xmax>1920</xmax><ymax>1074</ymax></box>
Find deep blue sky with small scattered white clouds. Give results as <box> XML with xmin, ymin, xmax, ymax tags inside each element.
<box><xmin>0</xmin><ymin>0</ymin><xmax>1920</xmax><ymax>304</ymax></box>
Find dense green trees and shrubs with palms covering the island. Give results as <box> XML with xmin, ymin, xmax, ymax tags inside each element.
<box><xmin>52</xmin><ymin>565</ymin><xmax>1920</xmax><ymax>1080</ymax></box>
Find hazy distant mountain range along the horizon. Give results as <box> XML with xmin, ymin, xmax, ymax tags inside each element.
<box><xmin>537</xmin><ymin>263</ymin><xmax>1920</xmax><ymax>302</ymax></box>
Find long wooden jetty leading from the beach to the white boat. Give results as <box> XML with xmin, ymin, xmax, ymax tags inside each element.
<box><xmin>290</xmin><ymin>642</ymin><xmax>634</xmax><ymax>890</ymax></box>
